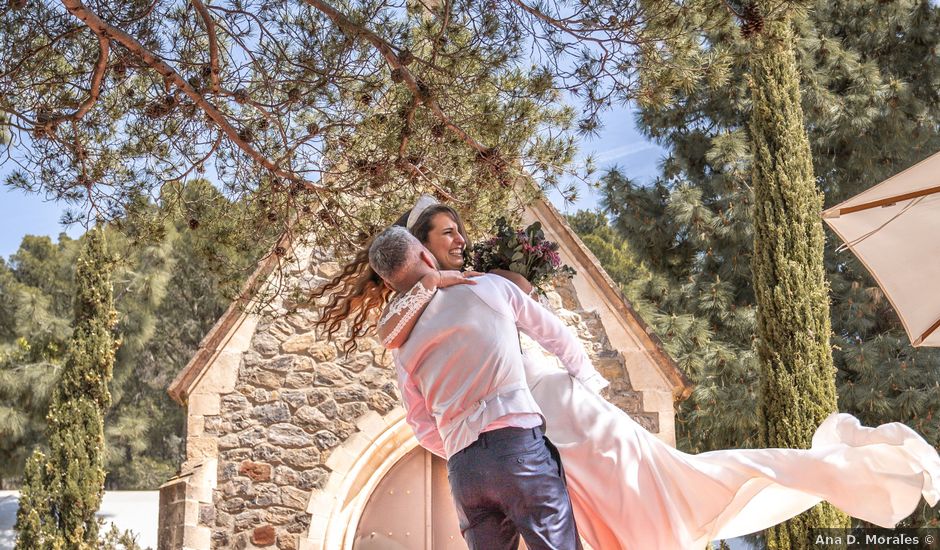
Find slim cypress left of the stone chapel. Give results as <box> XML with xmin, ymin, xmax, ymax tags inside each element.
<box><xmin>16</xmin><ymin>229</ymin><xmax>116</xmax><ymax>550</ymax></box>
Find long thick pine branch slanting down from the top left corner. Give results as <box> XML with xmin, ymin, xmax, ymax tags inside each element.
<box><xmin>61</xmin><ymin>0</ymin><xmax>327</xmax><ymax>196</ymax></box>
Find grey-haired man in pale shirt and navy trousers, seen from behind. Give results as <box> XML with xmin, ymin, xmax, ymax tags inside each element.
<box><xmin>369</xmin><ymin>227</ymin><xmax>606</xmax><ymax>550</ymax></box>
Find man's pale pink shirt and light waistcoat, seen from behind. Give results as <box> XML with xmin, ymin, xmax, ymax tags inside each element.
<box><xmin>394</xmin><ymin>275</ymin><xmax>607</xmax><ymax>459</ymax></box>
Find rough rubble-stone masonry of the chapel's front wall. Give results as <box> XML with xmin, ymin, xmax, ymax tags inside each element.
<box><xmin>199</xmin><ymin>259</ymin><xmax>659</xmax><ymax>550</ymax></box>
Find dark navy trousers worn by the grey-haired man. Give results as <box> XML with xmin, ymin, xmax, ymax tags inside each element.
<box><xmin>447</xmin><ymin>428</ymin><xmax>581</xmax><ymax>550</ymax></box>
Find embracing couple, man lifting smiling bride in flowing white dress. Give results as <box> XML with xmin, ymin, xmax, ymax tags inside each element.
<box><xmin>315</xmin><ymin>197</ymin><xmax>940</xmax><ymax>550</ymax></box>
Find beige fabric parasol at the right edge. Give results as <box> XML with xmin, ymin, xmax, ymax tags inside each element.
<box><xmin>823</xmin><ymin>153</ymin><xmax>940</xmax><ymax>346</ymax></box>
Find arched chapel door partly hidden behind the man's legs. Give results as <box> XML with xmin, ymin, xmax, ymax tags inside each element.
<box><xmin>353</xmin><ymin>447</ymin><xmax>467</xmax><ymax>550</ymax></box>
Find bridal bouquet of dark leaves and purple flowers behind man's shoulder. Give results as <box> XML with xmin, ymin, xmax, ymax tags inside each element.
<box><xmin>473</xmin><ymin>218</ymin><xmax>575</xmax><ymax>294</ymax></box>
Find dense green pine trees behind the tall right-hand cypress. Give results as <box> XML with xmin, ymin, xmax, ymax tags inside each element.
<box><xmin>580</xmin><ymin>0</ymin><xmax>940</xmax><ymax>466</ymax></box>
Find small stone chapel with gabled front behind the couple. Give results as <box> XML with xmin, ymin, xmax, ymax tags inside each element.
<box><xmin>158</xmin><ymin>199</ymin><xmax>691</xmax><ymax>550</ymax></box>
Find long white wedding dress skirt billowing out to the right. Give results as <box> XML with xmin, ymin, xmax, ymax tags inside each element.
<box><xmin>525</xmin><ymin>346</ymin><xmax>940</xmax><ymax>550</ymax></box>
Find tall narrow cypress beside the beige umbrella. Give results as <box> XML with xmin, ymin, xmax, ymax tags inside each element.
<box><xmin>745</xmin><ymin>6</ymin><xmax>848</xmax><ymax>549</ymax></box>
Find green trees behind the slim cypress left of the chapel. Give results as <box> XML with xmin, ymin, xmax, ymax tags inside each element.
<box><xmin>0</xmin><ymin>180</ymin><xmax>262</xmax><ymax>490</ymax></box>
